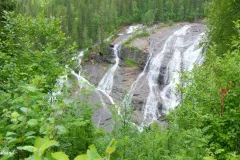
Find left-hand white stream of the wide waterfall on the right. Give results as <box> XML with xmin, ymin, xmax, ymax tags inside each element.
<box><xmin>143</xmin><ymin>25</ymin><xmax>190</xmax><ymax>123</ymax></box>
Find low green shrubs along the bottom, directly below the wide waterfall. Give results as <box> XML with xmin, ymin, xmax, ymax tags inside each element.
<box><xmin>96</xmin><ymin>113</ymin><xmax>208</xmax><ymax>160</ymax></box>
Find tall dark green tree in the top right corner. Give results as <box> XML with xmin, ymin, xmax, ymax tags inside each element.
<box><xmin>206</xmin><ymin>0</ymin><xmax>240</xmax><ymax>56</ymax></box>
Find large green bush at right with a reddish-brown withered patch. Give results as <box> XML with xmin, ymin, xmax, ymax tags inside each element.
<box><xmin>170</xmin><ymin>22</ymin><xmax>240</xmax><ymax>159</ymax></box>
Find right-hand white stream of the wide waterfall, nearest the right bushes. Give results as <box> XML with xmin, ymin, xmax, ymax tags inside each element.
<box><xmin>160</xmin><ymin>34</ymin><xmax>203</xmax><ymax>113</ymax></box>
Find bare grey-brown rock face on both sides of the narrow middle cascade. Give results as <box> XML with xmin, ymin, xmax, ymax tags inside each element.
<box><xmin>82</xmin><ymin>45</ymin><xmax>147</xmax><ymax>131</ymax></box>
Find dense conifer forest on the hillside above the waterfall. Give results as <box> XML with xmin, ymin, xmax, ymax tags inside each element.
<box><xmin>13</xmin><ymin>0</ymin><xmax>206</xmax><ymax>48</ymax></box>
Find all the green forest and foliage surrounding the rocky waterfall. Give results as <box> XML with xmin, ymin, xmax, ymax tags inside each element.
<box><xmin>0</xmin><ymin>0</ymin><xmax>240</xmax><ymax>160</ymax></box>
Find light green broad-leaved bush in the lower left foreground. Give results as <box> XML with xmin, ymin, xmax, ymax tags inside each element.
<box><xmin>1</xmin><ymin>77</ymin><xmax>94</xmax><ymax>157</ymax></box>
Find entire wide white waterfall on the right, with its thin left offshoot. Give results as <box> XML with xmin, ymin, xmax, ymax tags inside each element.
<box><xmin>123</xmin><ymin>25</ymin><xmax>201</xmax><ymax>126</ymax></box>
